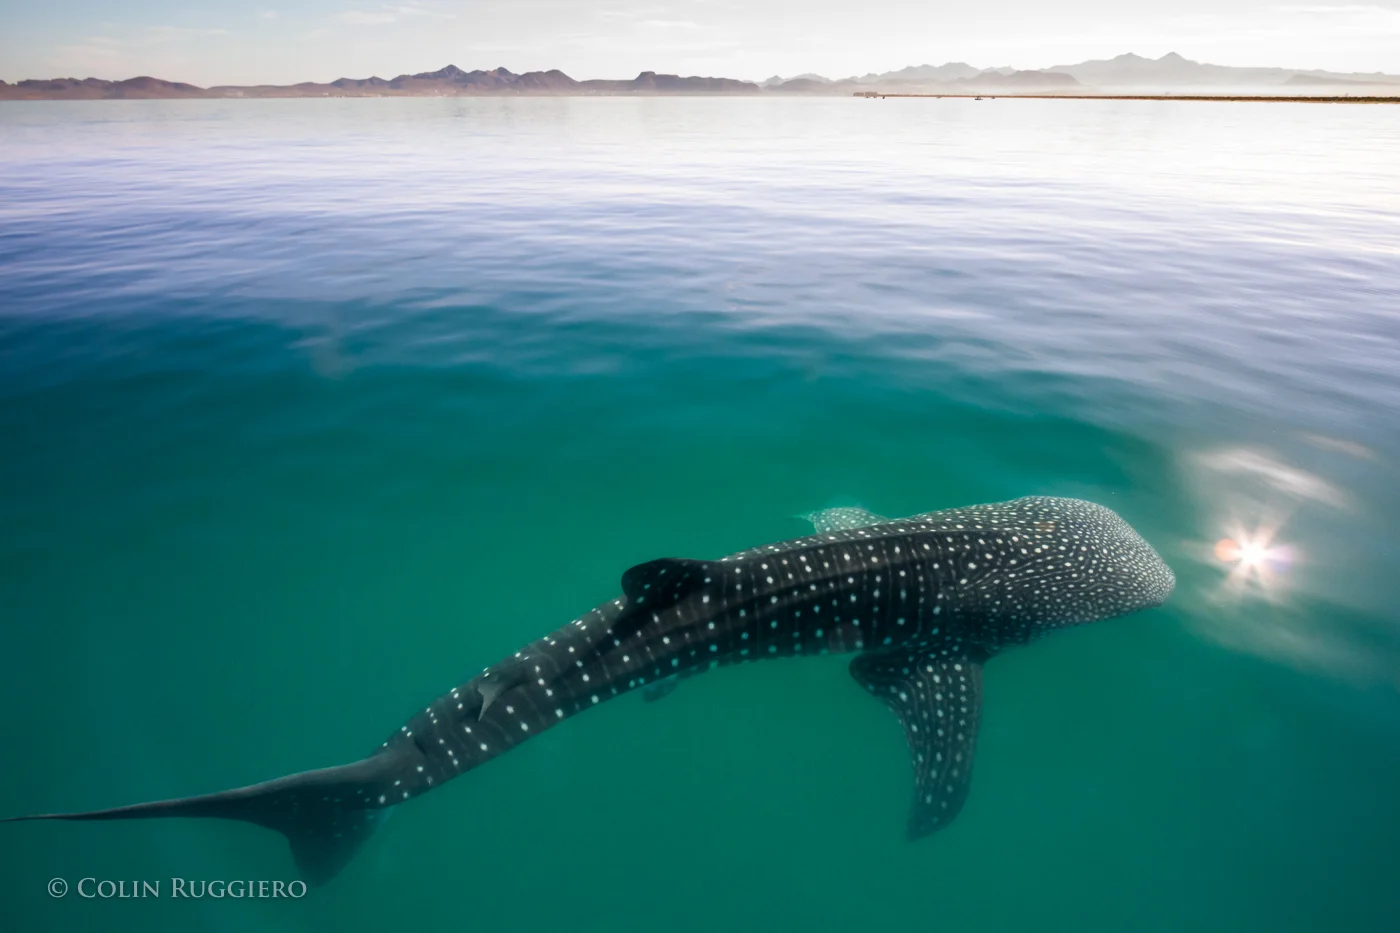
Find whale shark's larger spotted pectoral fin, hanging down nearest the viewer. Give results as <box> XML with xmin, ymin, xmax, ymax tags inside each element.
<box><xmin>851</xmin><ymin>649</ymin><xmax>981</xmax><ymax>839</ymax></box>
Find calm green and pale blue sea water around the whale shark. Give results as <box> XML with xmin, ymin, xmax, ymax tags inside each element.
<box><xmin>0</xmin><ymin>98</ymin><xmax>1400</xmax><ymax>933</ymax></box>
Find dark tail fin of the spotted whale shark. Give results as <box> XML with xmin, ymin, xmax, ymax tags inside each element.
<box><xmin>0</xmin><ymin>756</ymin><xmax>388</xmax><ymax>885</ymax></box>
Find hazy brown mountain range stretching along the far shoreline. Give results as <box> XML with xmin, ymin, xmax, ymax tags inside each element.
<box><xmin>0</xmin><ymin>52</ymin><xmax>1400</xmax><ymax>101</ymax></box>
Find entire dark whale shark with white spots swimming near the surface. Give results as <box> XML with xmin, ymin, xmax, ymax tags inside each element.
<box><xmin>0</xmin><ymin>496</ymin><xmax>1176</xmax><ymax>885</ymax></box>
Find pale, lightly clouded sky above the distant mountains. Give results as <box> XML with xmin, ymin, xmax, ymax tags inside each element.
<box><xmin>0</xmin><ymin>0</ymin><xmax>1400</xmax><ymax>87</ymax></box>
